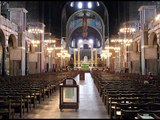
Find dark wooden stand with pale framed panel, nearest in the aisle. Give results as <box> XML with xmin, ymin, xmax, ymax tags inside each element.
<box><xmin>59</xmin><ymin>78</ymin><xmax>79</xmax><ymax>111</ymax></box>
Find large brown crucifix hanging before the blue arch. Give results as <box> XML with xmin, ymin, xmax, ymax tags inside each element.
<box><xmin>76</xmin><ymin>10</ymin><xmax>95</xmax><ymax>37</ymax></box>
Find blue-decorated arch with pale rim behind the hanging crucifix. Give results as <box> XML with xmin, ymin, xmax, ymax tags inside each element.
<box><xmin>66</xmin><ymin>9</ymin><xmax>105</xmax><ymax>48</ymax></box>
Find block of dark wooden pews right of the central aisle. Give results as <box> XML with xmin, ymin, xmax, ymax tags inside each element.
<box><xmin>91</xmin><ymin>71</ymin><xmax>160</xmax><ymax>119</ymax></box>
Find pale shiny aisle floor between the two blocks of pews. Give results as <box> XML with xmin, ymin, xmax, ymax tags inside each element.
<box><xmin>23</xmin><ymin>73</ymin><xmax>109</xmax><ymax>119</ymax></box>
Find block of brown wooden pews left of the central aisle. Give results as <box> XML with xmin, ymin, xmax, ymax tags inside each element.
<box><xmin>0</xmin><ymin>71</ymin><xmax>78</xmax><ymax>119</ymax></box>
